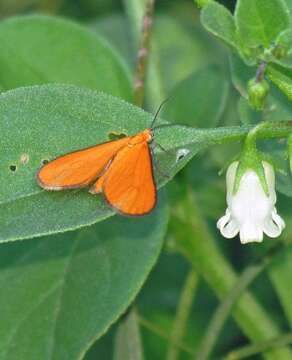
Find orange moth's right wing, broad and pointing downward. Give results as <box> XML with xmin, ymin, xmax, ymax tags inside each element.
<box><xmin>103</xmin><ymin>142</ymin><xmax>156</xmax><ymax>215</ymax></box>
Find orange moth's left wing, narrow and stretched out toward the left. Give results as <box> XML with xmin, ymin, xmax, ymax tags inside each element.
<box><xmin>37</xmin><ymin>137</ymin><xmax>129</xmax><ymax>190</ymax></box>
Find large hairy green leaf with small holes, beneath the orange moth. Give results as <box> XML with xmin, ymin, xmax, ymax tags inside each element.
<box><xmin>0</xmin><ymin>85</ymin><xmax>246</xmax><ymax>241</ymax></box>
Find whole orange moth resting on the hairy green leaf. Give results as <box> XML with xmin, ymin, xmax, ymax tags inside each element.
<box><xmin>37</xmin><ymin>129</ymin><xmax>157</xmax><ymax>216</ymax></box>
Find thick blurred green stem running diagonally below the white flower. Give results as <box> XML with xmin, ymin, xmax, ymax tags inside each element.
<box><xmin>170</xmin><ymin>190</ymin><xmax>292</xmax><ymax>360</ymax></box>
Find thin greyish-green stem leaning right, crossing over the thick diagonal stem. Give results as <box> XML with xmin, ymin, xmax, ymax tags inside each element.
<box><xmin>196</xmin><ymin>244</ymin><xmax>283</xmax><ymax>360</ymax></box>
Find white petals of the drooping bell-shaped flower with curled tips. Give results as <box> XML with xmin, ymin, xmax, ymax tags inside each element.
<box><xmin>217</xmin><ymin>161</ymin><xmax>285</xmax><ymax>244</ymax></box>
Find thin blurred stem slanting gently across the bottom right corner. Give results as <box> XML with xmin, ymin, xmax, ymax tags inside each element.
<box><xmin>224</xmin><ymin>333</ymin><xmax>292</xmax><ymax>360</ymax></box>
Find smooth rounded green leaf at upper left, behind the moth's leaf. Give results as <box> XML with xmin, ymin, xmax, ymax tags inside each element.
<box><xmin>0</xmin><ymin>16</ymin><xmax>132</xmax><ymax>100</ymax></box>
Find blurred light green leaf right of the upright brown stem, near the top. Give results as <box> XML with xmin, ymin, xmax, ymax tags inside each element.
<box><xmin>148</xmin><ymin>14</ymin><xmax>225</xmax><ymax>93</ymax></box>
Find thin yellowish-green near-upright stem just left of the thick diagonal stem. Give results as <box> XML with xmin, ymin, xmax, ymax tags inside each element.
<box><xmin>166</xmin><ymin>270</ymin><xmax>198</xmax><ymax>360</ymax></box>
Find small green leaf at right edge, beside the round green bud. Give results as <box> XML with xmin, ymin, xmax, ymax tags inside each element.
<box><xmin>267</xmin><ymin>64</ymin><xmax>292</xmax><ymax>100</ymax></box>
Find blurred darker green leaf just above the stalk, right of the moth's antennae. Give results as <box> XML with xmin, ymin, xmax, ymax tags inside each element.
<box><xmin>162</xmin><ymin>66</ymin><xmax>229</xmax><ymax>127</ymax></box>
